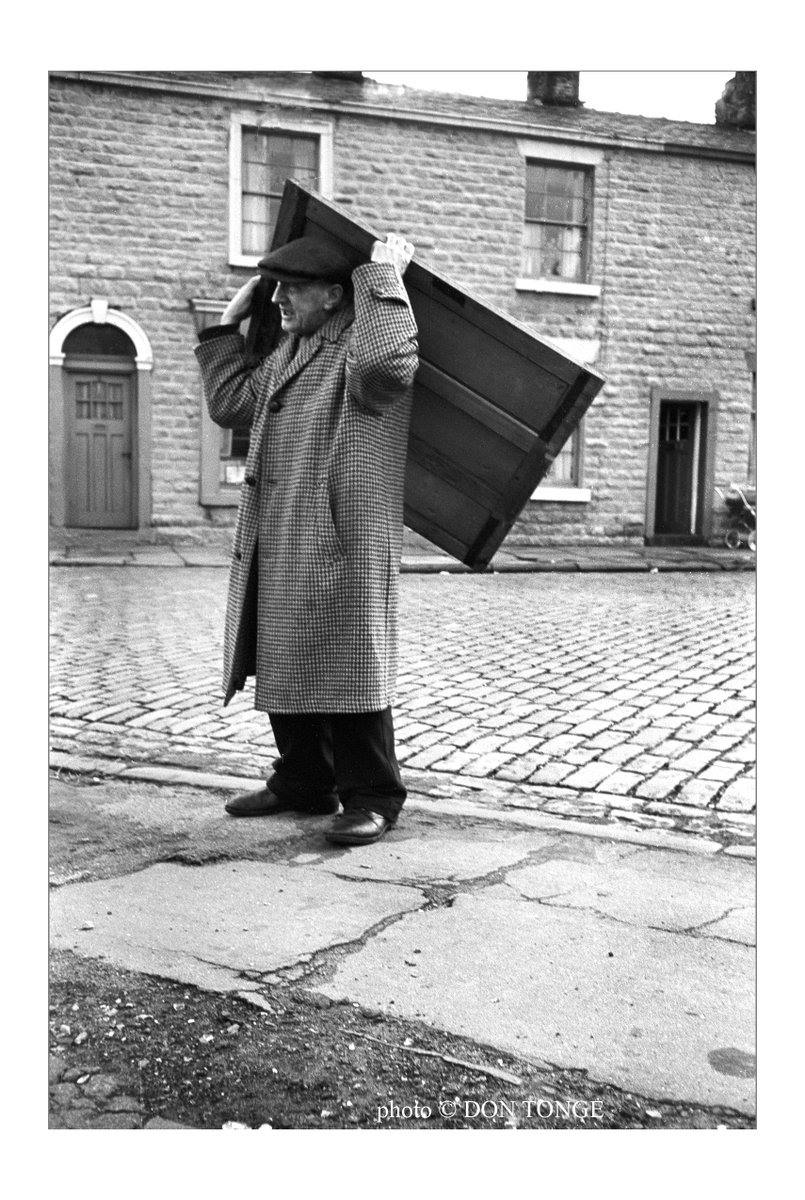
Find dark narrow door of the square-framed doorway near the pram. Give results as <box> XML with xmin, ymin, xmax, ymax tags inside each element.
<box><xmin>654</xmin><ymin>401</ymin><xmax>698</xmax><ymax>535</ymax></box>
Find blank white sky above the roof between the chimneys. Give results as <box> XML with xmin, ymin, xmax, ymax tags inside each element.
<box><xmin>366</xmin><ymin>71</ymin><xmax>735</xmax><ymax>125</ymax></box>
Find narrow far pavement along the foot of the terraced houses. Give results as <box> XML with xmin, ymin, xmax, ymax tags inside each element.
<box><xmin>49</xmin><ymin>529</ymin><xmax>756</xmax><ymax>574</ymax></box>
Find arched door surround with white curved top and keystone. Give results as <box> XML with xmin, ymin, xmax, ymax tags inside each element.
<box><xmin>48</xmin><ymin>299</ymin><xmax>154</xmax><ymax>529</ymax></box>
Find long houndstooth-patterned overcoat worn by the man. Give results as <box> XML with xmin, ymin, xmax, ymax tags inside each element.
<box><xmin>196</xmin><ymin>263</ymin><xmax>419</xmax><ymax>713</ymax></box>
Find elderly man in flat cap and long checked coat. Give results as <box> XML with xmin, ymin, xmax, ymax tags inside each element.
<box><xmin>196</xmin><ymin>234</ymin><xmax>419</xmax><ymax>845</ymax></box>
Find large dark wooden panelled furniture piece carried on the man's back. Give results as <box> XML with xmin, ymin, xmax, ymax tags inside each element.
<box><xmin>260</xmin><ymin>180</ymin><xmax>603</xmax><ymax>570</ymax></box>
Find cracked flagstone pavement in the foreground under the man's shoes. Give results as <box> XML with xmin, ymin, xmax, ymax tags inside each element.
<box><xmin>50</xmin><ymin>774</ymin><xmax>755</xmax><ymax>1116</ymax></box>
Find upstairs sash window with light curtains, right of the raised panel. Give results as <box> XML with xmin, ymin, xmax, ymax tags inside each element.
<box><xmin>522</xmin><ymin>161</ymin><xmax>591</xmax><ymax>283</ymax></box>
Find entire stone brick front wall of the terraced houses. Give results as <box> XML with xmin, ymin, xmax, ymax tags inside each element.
<box><xmin>50</xmin><ymin>77</ymin><xmax>755</xmax><ymax>542</ymax></box>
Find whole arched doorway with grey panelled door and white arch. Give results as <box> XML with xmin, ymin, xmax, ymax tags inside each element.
<box><xmin>50</xmin><ymin>300</ymin><xmax>152</xmax><ymax>529</ymax></box>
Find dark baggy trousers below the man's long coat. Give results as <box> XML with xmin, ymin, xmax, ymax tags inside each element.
<box><xmin>269</xmin><ymin>708</ymin><xmax>405</xmax><ymax>821</ymax></box>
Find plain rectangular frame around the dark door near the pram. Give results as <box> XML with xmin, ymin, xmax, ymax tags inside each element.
<box><xmin>645</xmin><ymin>386</ymin><xmax>719</xmax><ymax>544</ymax></box>
